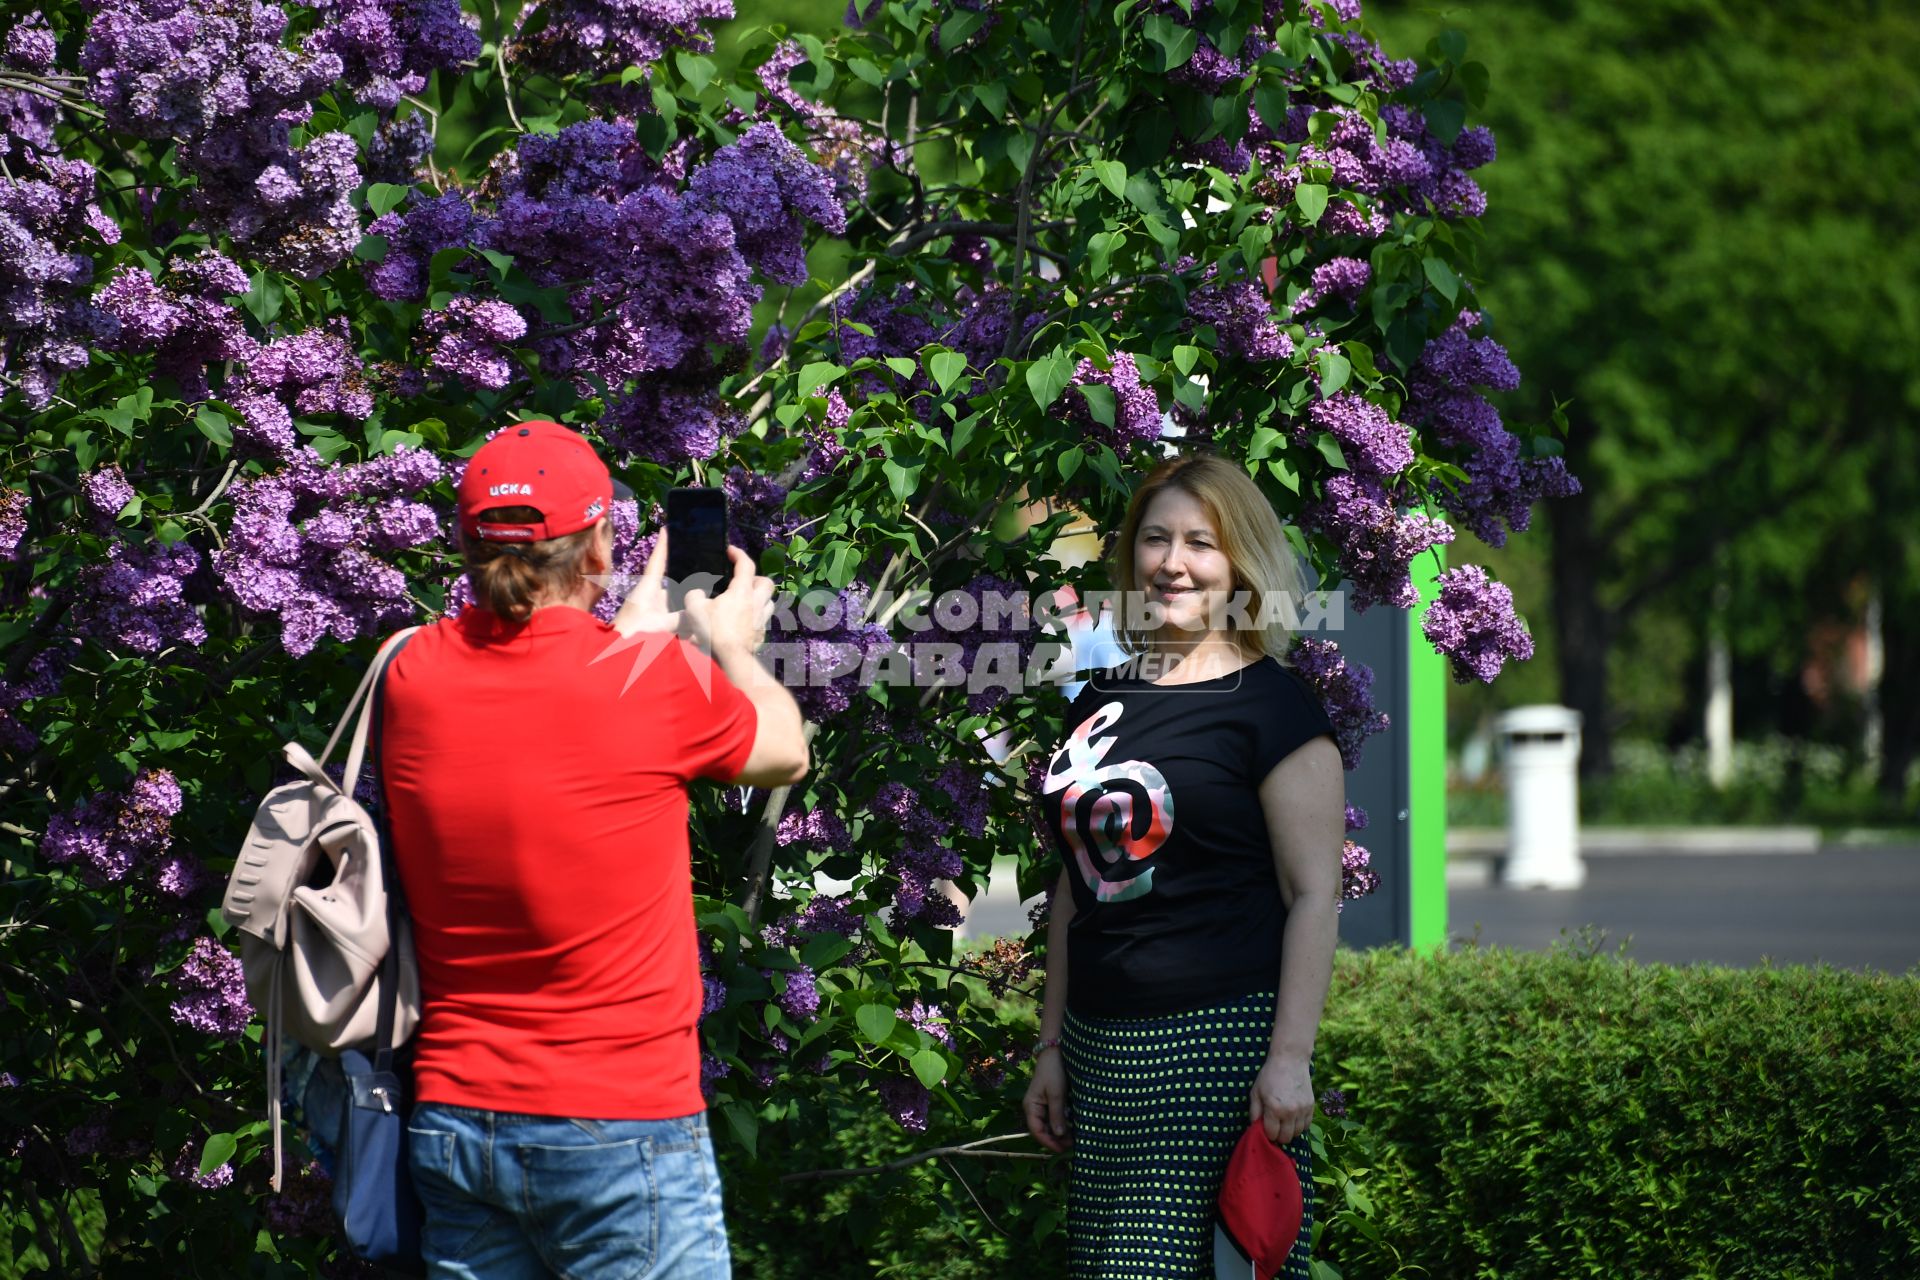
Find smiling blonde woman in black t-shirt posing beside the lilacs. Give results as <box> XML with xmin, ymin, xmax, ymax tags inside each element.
<box><xmin>1025</xmin><ymin>453</ymin><xmax>1346</xmax><ymax>1280</ymax></box>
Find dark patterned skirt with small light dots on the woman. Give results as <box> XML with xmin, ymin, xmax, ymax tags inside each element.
<box><xmin>1062</xmin><ymin>992</ymin><xmax>1313</xmax><ymax>1280</ymax></box>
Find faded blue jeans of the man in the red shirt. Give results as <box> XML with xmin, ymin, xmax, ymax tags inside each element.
<box><xmin>407</xmin><ymin>1102</ymin><xmax>732</xmax><ymax>1280</ymax></box>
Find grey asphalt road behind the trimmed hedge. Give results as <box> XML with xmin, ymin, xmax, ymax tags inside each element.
<box><xmin>966</xmin><ymin>848</ymin><xmax>1920</xmax><ymax>973</ymax></box>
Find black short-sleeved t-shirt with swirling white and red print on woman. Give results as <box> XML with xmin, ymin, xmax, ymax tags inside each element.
<box><xmin>1041</xmin><ymin>658</ymin><xmax>1332</xmax><ymax>1017</ymax></box>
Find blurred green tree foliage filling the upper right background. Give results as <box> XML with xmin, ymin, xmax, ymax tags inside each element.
<box><xmin>1375</xmin><ymin>0</ymin><xmax>1920</xmax><ymax>782</ymax></box>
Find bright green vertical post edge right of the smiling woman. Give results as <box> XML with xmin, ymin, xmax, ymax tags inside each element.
<box><xmin>1407</xmin><ymin>547</ymin><xmax>1448</xmax><ymax>948</ymax></box>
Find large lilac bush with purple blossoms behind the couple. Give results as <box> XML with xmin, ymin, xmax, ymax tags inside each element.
<box><xmin>0</xmin><ymin>0</ymin><xmax>1576</xmax><ymax>1274</ymax></box>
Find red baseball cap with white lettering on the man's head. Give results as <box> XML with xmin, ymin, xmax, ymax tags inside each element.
<box><xmin>459</xmin><ymin>420</ymin><xmax>634</xmax><ymax>543</ymax></box>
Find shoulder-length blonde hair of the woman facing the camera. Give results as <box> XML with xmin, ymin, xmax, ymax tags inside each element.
<box><xmin>1112</xmin><ymin>453</ymin><xmax>1306</xmax><ymax>662</ymax></box>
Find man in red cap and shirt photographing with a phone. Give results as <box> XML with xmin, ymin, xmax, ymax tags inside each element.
<box><xmin>380</xmin><ymin>422</ymin><xmax>806</xmax><ymax>1280</ymax></box>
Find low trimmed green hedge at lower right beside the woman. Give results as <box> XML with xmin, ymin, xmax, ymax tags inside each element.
<box><xmin>1319</xmin><ymin>940</ymin><xmax>1920</xmax><ymax>1280</ymax></box>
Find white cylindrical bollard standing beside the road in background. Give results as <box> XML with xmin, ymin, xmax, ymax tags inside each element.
<box><xmin>1494</xmin><ymin>706</ymin><xmax>1586</xmax><ymax>889</ymax></box>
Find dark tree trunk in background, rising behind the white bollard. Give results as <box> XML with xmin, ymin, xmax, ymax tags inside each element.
<box><xmin>1548</xmin><ymin>483</ymin><xmax>1615</xmax><ymax>777</ymax></box>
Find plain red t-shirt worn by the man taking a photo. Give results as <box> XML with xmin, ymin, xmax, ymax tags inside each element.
<box><xmin>382</xmin><ymin>606</ymin><xmax>756</xmax><ymax>1121</ymax></box>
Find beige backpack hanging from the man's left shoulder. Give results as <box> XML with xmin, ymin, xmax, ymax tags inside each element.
<box><xmin>221</xmin><ymin>628</ymin><xmax>420</xmax><ymax>1190</ymax></box>
